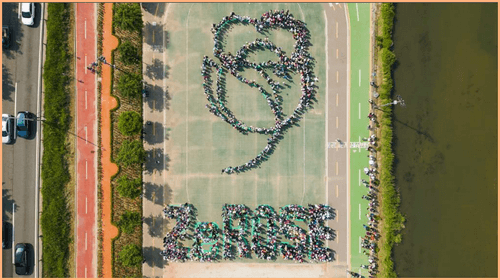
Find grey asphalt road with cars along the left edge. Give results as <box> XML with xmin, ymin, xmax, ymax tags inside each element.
<box><xmin>2</xmin><ymin>3</ymin><xmax>41</xmax><ymax>277</ymax></box>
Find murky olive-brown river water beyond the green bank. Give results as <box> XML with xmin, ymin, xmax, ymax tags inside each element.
<box><xmin>394</xmin><ymin>3</ymin><xmax>498</xmax><ymax>277</ymax></box>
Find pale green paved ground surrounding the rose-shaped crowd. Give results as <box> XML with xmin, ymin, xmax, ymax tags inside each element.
<box><xmin>165</xmin><ymin>3</ymin><xmax>326</xmax><ymax>262</ymax></box>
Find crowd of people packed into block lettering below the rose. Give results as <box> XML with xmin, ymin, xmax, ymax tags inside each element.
<box><xmin>160</xmin><ymin>204</ymin><xmax>335</xmax><ymax>263</ymax></box>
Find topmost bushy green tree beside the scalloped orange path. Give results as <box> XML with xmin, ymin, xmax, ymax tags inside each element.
<box><xmin>113</xmin><ymin>3</ymin><xmax>143</xmax><ymax>32</ymax></box>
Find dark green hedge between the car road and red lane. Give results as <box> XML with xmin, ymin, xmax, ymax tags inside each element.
<box><xmin>40</xmin><ymin>3</ymin><xmax>72</xmax><ymax>278</ymax></box>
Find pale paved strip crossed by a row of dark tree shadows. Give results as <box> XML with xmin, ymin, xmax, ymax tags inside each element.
<box><xmin>142</xmin><ymin>3</ymin><xmax>170</xmax><ymax>278</ymax></box>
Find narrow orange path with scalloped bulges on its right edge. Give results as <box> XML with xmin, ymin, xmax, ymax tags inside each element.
<box><xmin>100</xmin><ymin>3</ymin><xmax>118</xmax><ymax>278</ymax></box>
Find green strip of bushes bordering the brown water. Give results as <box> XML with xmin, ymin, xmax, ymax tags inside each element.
<box><xmin>377</xmin><ymin>3</ymin><xmax>405</xmax><ymax>278</ymax></box>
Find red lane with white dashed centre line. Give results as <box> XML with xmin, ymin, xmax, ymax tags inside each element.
<box><xmin>75</xmin><ymin>3</ymin><xmax>99</xmax><ymax>278</ymax></box>
